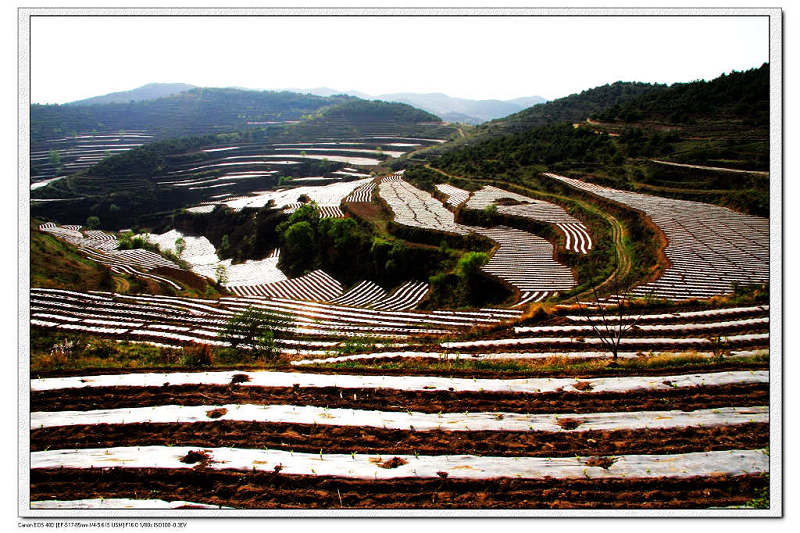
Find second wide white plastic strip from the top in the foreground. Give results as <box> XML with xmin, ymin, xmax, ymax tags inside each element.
<box><xmin>31</xmin><ymin>404</ymin><xmax>769</xmax><ymax>432</ymax></box>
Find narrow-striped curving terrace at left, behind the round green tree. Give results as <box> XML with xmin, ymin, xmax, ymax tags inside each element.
<box><xmin>31</xmin><ymin>288</ymin><xmax>519</xmax><ymax>348</ymax></box>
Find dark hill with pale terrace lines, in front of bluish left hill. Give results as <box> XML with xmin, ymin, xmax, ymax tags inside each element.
<box><xmin>31</xmin><ymin>99</ymin><xmax>454</xmax><ymax>228</ymax></box>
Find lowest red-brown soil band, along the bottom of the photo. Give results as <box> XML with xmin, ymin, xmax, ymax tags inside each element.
<box><xmin>31</xmin><ymin>468</ymin><xmax>769</xmax><ymax>509</ymax></box>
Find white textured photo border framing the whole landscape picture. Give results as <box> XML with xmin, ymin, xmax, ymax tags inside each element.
<box><xmin>17</xmin><ymin>8</ymin><xmax>784</xmax><ymax>519</ymax></box>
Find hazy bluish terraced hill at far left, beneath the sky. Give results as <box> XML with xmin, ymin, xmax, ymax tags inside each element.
<box><xmin>30</xmin><ymin>88</ymin><xmax>360</xmax><ymax>183</ymax></box>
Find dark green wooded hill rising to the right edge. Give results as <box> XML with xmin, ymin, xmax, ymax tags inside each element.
<box><xmin>418</xmin><ymin>65</ymin><xmax>769</xmax><ymax>216</ymax></box>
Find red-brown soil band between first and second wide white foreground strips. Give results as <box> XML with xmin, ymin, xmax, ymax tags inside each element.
<box><xmin>30</xmin><ymin>383</ymin><xmax>769</xmax><ymax>414</ymax></box>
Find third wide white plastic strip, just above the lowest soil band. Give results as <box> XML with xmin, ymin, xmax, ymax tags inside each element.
<box><xmin>31</xmin><ymin>446</ymin><xmax>769</xmax><ymax>479</ymax></box>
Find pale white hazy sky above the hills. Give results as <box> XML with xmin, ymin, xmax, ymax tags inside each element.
<box><xmin>30</xmin><ymin>16</ymin><xmax>769</xmax><ymax>103</ymax></box>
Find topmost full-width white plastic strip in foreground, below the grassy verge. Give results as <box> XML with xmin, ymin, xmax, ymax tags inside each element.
<box><xmin>31</xmin><ymin>370</ymin><xmax>769</xmax><ymax>393</ymax></box>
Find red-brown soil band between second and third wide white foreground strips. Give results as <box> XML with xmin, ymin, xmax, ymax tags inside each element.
<box><xmin>31</xmin><ymin>420</ymin><xmax>769</xmax><ymax>457</ymax></box>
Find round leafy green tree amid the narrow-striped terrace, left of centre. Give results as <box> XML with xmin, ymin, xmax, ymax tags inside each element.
<box><xmin>218</xmin><ymin>306</ymin><xmax>292</xmax><ymax>360</ymax></box>
